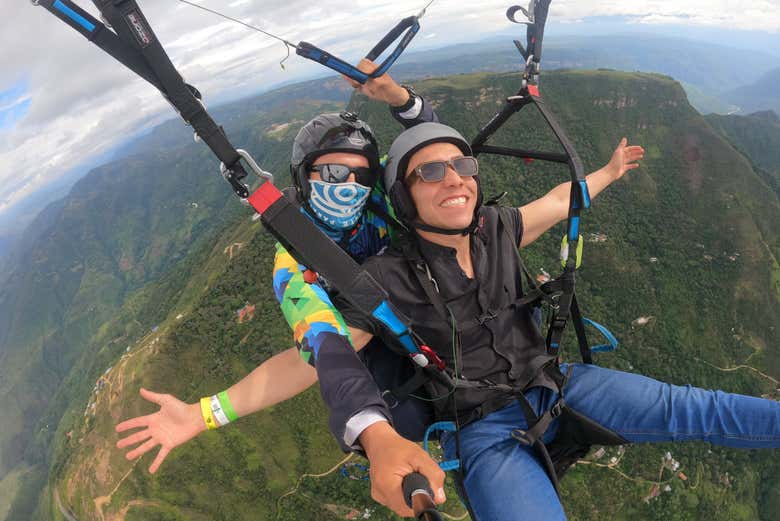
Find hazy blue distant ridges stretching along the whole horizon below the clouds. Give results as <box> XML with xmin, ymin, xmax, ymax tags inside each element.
<box><xmin>6</xmin><ymin>34</ymin><xmax>780</xmax><ymax>246</ymax></box>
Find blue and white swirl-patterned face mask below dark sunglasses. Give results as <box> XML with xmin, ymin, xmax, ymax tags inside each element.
<box><xmin>309</xmin><ymin>180</ymin><xmax>371</xmax><ymax>230</ymax></box>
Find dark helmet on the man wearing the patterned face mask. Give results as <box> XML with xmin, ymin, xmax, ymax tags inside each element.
<box><xmin>290</xmin><ymin>112</ymin><xmax>379</xmax><ymax>202</ymax></box>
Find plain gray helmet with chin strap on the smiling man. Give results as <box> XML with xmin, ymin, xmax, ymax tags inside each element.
<box><xmin>383</xmin><ymin>123</ymin><xmax>482</xmax><ymax>235</ymax></box>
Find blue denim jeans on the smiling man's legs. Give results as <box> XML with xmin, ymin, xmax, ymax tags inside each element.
<box><xmin>442</xmin><ymin>364</ymin><xmax>780</xmax><ymax>521</ymax></box>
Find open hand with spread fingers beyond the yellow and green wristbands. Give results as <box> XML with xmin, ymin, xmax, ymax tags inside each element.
<box><xmin>115</xmin><ymin>388</ymin><xmax>206</xmax><ymax>474</ymax></box>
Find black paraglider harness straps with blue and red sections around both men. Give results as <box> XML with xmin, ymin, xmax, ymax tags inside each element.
<box><xmin>38</xmin><ymin>0</ymin><xmax>625</xmax><ymax>515</ymax></box>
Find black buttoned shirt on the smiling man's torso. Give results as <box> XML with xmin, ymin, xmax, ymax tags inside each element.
<box><xmin>358</xmin><ymin>207</ymin><xmax>556</xmax><ymax>425</ymax></box>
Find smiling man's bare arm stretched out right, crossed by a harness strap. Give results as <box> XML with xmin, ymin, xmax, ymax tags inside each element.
<box><xmin>519</xmin><ymin>138</ymin><xmax>645</xmax><ymax>247</ymax></box>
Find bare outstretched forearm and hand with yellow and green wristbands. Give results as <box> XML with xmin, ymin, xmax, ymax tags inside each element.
<box><xmin>116</xmin><ymin>348</ymin><xmax>317</xmax><ymax>474</ymax></box>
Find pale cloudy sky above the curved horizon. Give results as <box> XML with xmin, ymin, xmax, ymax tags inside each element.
<box><xmin>0</xmin><ymin>0</ymin><xmax>780</xmax><ymax>214</ymax></box>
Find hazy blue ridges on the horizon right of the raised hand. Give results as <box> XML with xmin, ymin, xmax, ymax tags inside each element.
<box><xmin>393</xmin><ymin>36</ymin><xmax>777</xmax><ymax>114</ymax></box>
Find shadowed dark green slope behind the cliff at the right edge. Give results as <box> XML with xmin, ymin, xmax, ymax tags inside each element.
<box><xmin>707</xmin><ymin>110</ymin><xmax>780</xmax><ymax>197</ymax></box>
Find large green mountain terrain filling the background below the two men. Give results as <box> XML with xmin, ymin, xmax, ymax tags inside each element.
<box><xmin>6</xmin><ymin>71</ymin><xmax>780</xmax><ymax>521</ymax></box>
